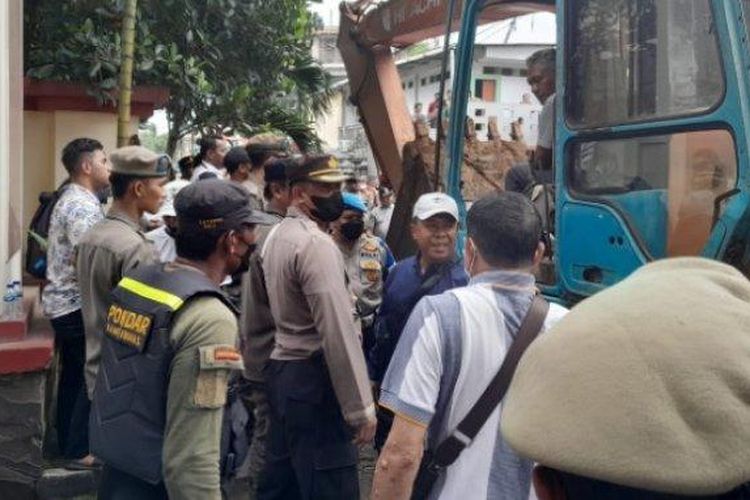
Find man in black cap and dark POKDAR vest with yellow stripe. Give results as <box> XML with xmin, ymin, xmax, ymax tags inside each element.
<box><xmin>90</xmin><ymin>179</ymin><xmax>276</xmax><ymax>500</ymax></box>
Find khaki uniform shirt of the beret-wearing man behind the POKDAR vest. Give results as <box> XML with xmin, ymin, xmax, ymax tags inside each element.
<box><xmin>76</xmin><ymin>208</ymin><xmax>159</xmax><ymax>399</ymax></box>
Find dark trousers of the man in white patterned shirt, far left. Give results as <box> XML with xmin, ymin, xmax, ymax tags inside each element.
<box><xmin>51</xmin><ymin>309</ymin><xmax>91</xmax><ymax>459</ymax></box>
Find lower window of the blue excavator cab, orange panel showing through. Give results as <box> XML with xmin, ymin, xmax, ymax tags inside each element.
<box><xmin>568</xmin><ymin>130</ymin><xmax>737</xmax><ymax>258</ymax></box>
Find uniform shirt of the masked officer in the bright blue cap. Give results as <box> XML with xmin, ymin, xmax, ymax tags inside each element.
<box><xmin>337</xmin><ymin>233</ymin><xmax>386</xmax><ymax>326</ymax></box>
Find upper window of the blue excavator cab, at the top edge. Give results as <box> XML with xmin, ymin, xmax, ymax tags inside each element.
<box><xmin>565</xmin><ymin>0</ymin><xmax>725</xmax><ymax>129</ymax></box>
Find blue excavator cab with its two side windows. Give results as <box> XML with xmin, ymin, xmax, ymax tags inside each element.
<box><xmin>447</xmin><ymin>0</ymin><xmax>750</xmax><ymax>303</ymax></box>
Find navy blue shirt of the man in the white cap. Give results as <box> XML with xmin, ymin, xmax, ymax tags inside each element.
<box><xmin>367</xmin><ymin>255</ymin><xmax>469</xmax><ymax>381</ymax></box>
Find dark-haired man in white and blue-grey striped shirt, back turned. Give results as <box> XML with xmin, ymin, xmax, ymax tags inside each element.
<box><xmin>372</xmin><ymin>193</ymin><xmax>566</xmax><ymax>500</ymax></box>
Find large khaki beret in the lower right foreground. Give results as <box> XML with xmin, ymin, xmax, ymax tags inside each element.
<box><xmin>502</xmin><ymin>258</ymin><xmax>750</xmax><ymax>495</ymax></box>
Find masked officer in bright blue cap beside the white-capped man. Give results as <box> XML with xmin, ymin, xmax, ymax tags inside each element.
<box><xmin>331</xmin><ymin>193</ymin><xmax>394</xmax><ymax>352</ymax></box>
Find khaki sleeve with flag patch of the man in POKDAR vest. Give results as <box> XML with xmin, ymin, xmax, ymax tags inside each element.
<box><xmin>162</xmin><ymin>278</ymin><xmax>242</xmax><ymax>500</ymax></box>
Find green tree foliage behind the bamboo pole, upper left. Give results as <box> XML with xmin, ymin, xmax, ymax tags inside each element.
<box><xmin>25</xmin><ymin>0</ymin><xmax>331</xmax><ymax>152</ymax></box>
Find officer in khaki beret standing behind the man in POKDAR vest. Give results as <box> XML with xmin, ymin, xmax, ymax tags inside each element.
<box><xmin>76</xmin><ymin>146</ymin><xmax>171</xmax><ymax>399</ymax></box>
